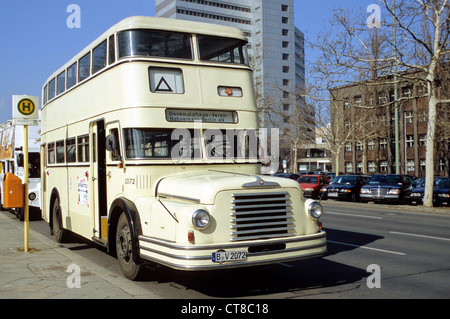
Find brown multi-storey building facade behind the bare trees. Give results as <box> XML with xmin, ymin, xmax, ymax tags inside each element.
<box><xmin>330</xmin><ymin>72</ymin><xmax>450</xmax><ymax>177</ymax></box>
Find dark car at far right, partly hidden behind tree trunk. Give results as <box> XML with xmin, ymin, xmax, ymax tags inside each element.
<box><xmin>410</xmin><ymin>177</ymin><xmax>450</xmax><ymax>206</ymax></box>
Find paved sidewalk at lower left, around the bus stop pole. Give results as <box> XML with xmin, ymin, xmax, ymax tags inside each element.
<box><xmin>0</xmin><ymin>212</ymin><xmax>160</xmax><ymax>299</ymax></box>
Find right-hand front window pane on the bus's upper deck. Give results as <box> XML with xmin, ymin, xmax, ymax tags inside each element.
<box><xmin>197</xmin><ymin>35</ymin><xmax>249</xmax><ymax>65</ymax></box>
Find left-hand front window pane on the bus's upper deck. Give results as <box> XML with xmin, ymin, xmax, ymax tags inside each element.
<box><xmin>118</xmin><ymin>30</ymin><xmax>192</xmax><ymax>60</ymax></box>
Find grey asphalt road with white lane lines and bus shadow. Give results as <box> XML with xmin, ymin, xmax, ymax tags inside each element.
<box><xmin>8</xmin><ymin>200</ymin><xmax>450</xmax><ymax>300</ymax></box>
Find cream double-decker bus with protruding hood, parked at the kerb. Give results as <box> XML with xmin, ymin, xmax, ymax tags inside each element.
<box><xmin>41</xmin><ymin>17</ymin><xmax>326</xmax><ymax>279</ymax></box>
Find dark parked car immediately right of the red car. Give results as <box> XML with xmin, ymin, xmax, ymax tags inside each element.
<box><xmin>322</xmin><ymin>175</ymin><xmax>366</xmax><ymax>202</ymax></box>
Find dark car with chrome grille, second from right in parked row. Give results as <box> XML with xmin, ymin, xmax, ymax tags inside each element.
<box><xmin>359</xmin><ymin>174</ymin><xmax>413</xmax><ymax>204</ymax></box>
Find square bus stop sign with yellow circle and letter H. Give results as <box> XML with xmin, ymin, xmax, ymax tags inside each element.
<box><xmin>12</xmin><ymin>95</ymin><xmax>39</xmax><ymax>125</ymax></box>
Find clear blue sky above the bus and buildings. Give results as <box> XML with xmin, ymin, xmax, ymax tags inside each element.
<box><xmin>0</xmin><ymin>0</ymin><xmax>377</xmax><ymax>123</ymax></box>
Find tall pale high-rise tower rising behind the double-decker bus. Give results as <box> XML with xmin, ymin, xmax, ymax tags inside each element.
<box><xmin>155</xmin><ymin>0</ymin><xmax>305</xmax><ymax>129</ymax></box>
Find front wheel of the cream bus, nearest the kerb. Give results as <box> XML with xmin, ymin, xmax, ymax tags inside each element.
<box><xmin>116</xmin><ymin>213</ymin><xmax>144</xmax><ymax>280</ymax></box>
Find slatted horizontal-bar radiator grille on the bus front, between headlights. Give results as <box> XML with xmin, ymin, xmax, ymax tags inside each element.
<box><xmin>230</xmin><ymin>192</ymin><xmax>294</xmax><ymax>241</ymax></box>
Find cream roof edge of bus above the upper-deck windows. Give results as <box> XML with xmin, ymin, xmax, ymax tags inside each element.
<box><xmin>44</xmin><ymin>16</ymin><xmax>247</xmax><ymax>86</ymax></box>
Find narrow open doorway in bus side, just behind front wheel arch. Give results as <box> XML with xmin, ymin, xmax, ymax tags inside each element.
<box><xmin>89</xmin><ymin>120</ymin><xmax>107</xmax><ymax>239</ymax></box>
